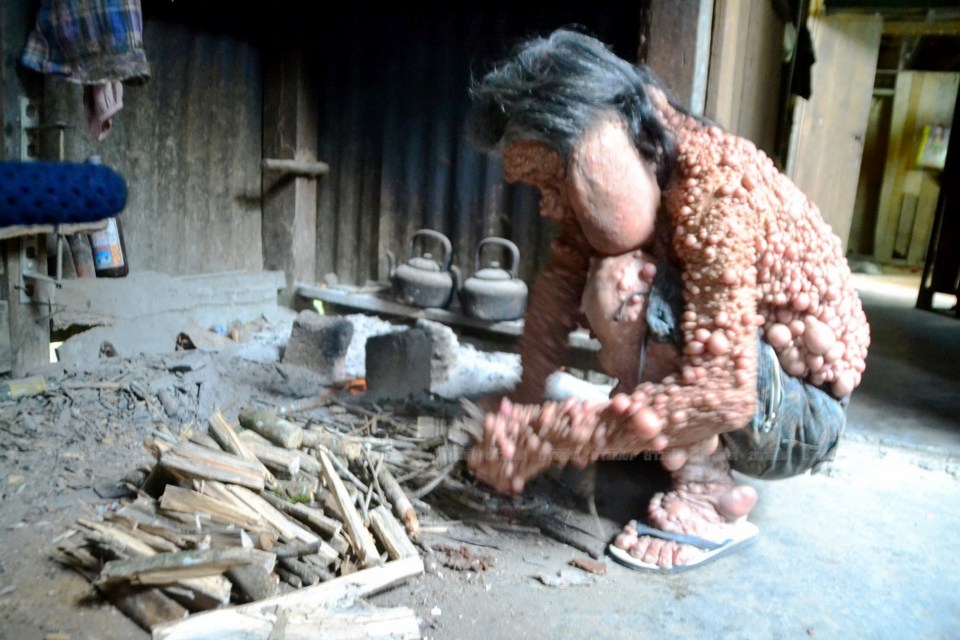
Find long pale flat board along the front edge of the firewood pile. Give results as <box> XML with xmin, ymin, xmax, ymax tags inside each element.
<box><xmin>153</xmin><ymin>556</ymin><xmax>423</xmax><ymax>640</ymax></box>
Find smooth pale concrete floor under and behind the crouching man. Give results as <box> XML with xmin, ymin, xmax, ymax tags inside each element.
<box><xmin>380</xmin><ymin>278</ymin><xmax>960</xmax><ymax>639</ymax></box>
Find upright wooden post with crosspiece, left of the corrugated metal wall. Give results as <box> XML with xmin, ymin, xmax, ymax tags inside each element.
<box><xmin>262</xmin><ymin>47</ymin><xmax>321</xmax><ymax>299</ymax></box>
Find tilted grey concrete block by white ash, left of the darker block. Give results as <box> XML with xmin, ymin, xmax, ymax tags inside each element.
<box><xmin>282</xmin><ymin>309</ymin><xmax>353</xmax><ymax>381</ymax></box>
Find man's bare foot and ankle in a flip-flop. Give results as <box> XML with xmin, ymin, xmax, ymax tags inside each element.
<box><xmin>614</xmin><ymin>450</ymin><xmax>757</xmax><ymax>569</ymax></box>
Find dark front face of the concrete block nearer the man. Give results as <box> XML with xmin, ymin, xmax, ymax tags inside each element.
<box><xmin>366</xmin><ymin>329</ymin><xmax>433</xmax><ymax>399</ymax></box>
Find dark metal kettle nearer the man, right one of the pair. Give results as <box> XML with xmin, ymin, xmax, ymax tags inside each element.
<box><xmin>458</xmin><ymin>237</ymin><xmax>527</xmax><ymax>320</ymax></box>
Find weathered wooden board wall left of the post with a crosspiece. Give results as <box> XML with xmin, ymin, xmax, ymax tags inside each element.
<box><xmin>44</xmin><ymin>20</ymin><xmax>263</xmax><ymax>275</ymax></box>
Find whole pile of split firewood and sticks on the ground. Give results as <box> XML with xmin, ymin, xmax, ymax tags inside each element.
<box><xmin>55</xmin><ymin>397</ymin><xmax>478</xmax><ymax>640</ymax></box>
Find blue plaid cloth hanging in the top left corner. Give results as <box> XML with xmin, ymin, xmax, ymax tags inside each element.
<box><xmin>20</xmin><ymin>0</ymin><xmax>150</xmax><ymax>85</ymax></box>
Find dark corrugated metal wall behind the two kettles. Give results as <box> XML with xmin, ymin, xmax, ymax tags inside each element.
<box><xmin>315</xmin><ymin>6</ymin><xmax>639</xmax><ymax>284</ymax></box>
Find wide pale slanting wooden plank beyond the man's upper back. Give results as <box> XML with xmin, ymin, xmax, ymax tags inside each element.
<box><xmin>787</xmin><ymin>15</ymin><xmax>883</xmax><ymax>251</ymax></box>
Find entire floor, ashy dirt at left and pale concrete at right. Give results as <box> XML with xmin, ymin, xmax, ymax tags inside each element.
<box><xmin>0</xmin><ymin>276</ymin><xmax>960</xmax><ymax>640</ymax></box>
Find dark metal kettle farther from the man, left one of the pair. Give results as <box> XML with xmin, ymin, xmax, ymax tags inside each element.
<box><xmin>386</xmin><ymin>229</ymin><xmax>459</xmax><ymax>308</ymax></box>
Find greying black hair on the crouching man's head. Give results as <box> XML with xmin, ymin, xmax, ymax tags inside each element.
<box><xmin>466</xmin><ymin>28</ymin><xmax>689</xmax><ymax>187</ymax></box>
